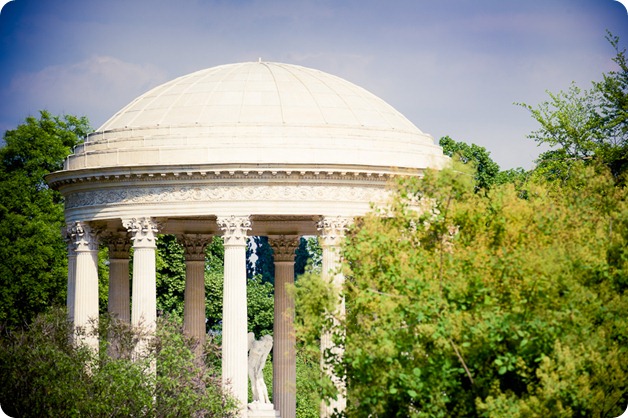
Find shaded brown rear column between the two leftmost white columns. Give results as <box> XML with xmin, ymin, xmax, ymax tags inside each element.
<box><xmin>105</xmin><ymin>234</ymin><xmax>131</xmax><ymax>323</ymax></box>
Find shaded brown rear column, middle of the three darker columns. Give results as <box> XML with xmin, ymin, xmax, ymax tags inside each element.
<box><xmin>179</xmin><ymin>234</ymin><xmax>211</xmax><ymax>355</ymax></box>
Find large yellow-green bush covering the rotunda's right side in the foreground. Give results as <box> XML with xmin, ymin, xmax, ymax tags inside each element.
<box><xmin>297</xmin><ymin>164</ymin><xmax>628</xmax><ymax>417</ymax></box>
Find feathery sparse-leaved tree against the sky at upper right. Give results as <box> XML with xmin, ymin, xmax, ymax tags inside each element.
<box><xmin>517</xmin><ymin>32</ymin><xmax>628</xmax><ymax>181</ymax></box>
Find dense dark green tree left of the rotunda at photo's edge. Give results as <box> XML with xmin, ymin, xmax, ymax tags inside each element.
<box><xmin>0</xmin><ymin>111</ymin><xmax>90</xmax><ymax>327</ymax></box>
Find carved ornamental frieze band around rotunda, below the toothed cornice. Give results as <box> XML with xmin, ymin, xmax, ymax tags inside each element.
<box><xmin>65</xmin><ymin>184</ymin><xmax>389</xmax><ymax>209</ymax></box>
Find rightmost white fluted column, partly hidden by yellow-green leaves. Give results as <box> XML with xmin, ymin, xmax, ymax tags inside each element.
<box><xmin>317</xmin><ymin>216</ymin><xmax>353</xmax><ymax>417</ymax></box>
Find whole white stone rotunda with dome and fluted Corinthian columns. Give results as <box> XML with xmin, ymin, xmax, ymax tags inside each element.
<box><xmin>48</xmin><ymin>62</ymin><xmax>448</xmax><ymax>418</ymax></box>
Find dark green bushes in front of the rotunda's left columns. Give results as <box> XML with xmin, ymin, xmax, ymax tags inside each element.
<box><xmin>0</xmin><ymin>310</ymin><xmax>233</xmax><ymax>417</ymax></box>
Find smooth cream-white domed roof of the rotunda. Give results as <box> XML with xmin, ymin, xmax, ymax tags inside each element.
<box><xmin>65</xmin><ymin>62</ymin><xmax>447</xmax><ymax>170</ymax></box>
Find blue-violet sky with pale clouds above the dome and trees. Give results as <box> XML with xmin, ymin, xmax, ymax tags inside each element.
<box><xmin>0</xmin><ymin>0</ymin><xmax>628</xmax><ymax>169</ymax></box>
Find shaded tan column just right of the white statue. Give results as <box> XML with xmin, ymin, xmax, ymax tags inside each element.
<box><xmin>268</xmin><ymin>235</ymin><xmax>299</xmax><ymax>418</ymax></box>
